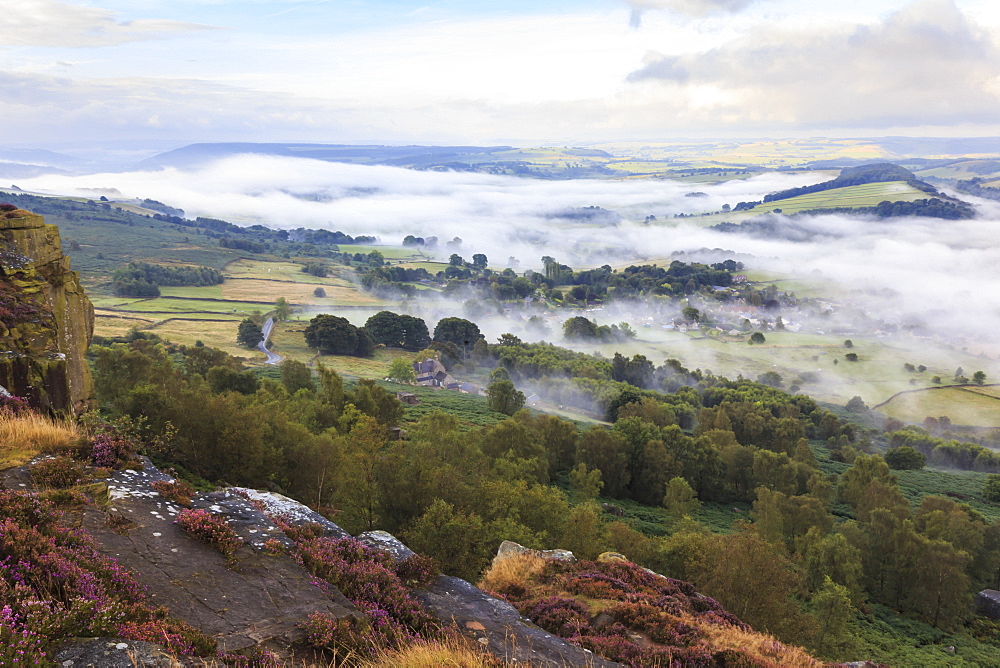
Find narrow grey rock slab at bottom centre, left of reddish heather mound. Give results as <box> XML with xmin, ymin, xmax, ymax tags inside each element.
<box><xmin>414</xmin><ymin>575</ymin><xmax>621</xmax><ymax>668</ymax></box>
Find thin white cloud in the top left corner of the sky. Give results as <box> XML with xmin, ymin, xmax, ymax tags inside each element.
<box><xmin>0</xmin><ymin>0</ymin><xmax>217</xmax><ymax>47</ymax></box>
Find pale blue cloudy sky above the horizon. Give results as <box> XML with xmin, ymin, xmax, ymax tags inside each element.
<box><xmin>0</xmin><ymin>0</ymin><xmax>1000</xmax><ymax>149</ymax></box>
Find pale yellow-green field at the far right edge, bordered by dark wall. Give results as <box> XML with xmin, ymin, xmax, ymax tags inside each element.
<box><xmin>879</xmin><ymin>387</ymin><xmax>1000</xmax><ymax>427</ymax></box>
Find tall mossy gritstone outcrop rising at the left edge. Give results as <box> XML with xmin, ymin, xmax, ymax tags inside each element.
<box><xmin>0</xmin><ymin>210</ymin><xmax>94</xmax><ymax>412</ymax></box>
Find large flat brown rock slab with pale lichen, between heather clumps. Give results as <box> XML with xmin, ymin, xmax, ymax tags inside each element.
<box><xmin>82</xmin><ymin>465</ymin><xmax>360</xmax><ymax>652</ymax></box>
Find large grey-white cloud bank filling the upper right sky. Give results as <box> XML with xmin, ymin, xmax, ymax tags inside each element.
<box><xmin>629</xmin><ymin>0</ymin><xmax>1000</xmax><ymax>128</ymax></box>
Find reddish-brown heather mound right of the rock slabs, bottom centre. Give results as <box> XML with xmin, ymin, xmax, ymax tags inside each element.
<box><xmin>495</xmin><ymin>561</ymin><xmax>767</xmax><ymax>668</ymax></box>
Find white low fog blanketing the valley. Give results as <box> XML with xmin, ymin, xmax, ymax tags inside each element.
<box><xmin>18</xmin><ymin>155</ymin><xmax>1000</xmax><ymax>380</ymax></box>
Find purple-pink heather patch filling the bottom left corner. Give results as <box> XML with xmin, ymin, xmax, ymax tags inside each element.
<box><xmin>0</xmin><ymin>490</ymin><xmax>216</xmax><ymax>665</ymax></box>
